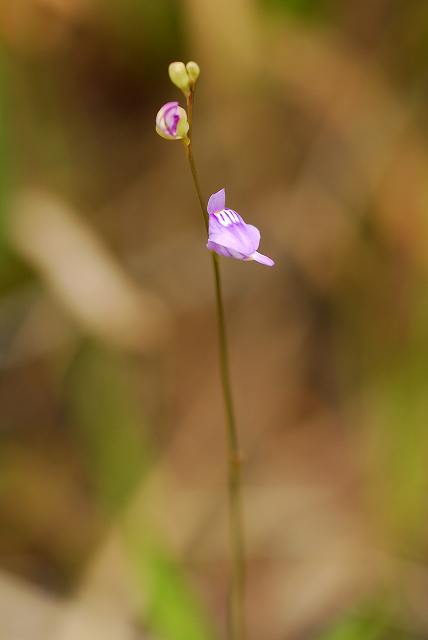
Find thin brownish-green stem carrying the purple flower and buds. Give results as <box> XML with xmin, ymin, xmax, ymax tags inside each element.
<box><xmin>184</xmin><ymin>92</ymin><xmax>246</xmax><ymax>640</ymax></box>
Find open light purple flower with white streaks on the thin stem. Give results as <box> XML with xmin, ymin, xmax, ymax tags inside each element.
<box><xmin>207</xmin><ymin>189</ymin><xmax>275</xmax><ymax>267</ymax></box>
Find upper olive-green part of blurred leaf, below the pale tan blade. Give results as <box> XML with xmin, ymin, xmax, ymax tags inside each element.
<box><xmin>71</xmin><ymin>346</ymin><xmax>151</xmax><ymax>513</ymax></box>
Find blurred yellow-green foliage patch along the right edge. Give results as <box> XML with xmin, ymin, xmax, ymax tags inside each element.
<box><xmin>368</xmin><ymin>292</ymin><xmax>428</xmax><ymax>556</ymax></box>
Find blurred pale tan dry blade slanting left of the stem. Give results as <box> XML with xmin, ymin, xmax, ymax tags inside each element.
<box><xmin>10</xmin><ymin>192</ymin><xmax>168</xmax><ymax>351</ymax></box>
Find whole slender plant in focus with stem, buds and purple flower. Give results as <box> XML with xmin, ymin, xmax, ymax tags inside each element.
<box><xmin>156</xmin><ymin>62</ymin><xmax>274</xmax><ymax>640</ymax></box>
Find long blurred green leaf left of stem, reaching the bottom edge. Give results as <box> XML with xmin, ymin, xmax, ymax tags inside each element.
<box><xmin>70</xmin><ymin>345</ymin><xmax>219</xmax><ymax>640</ymax></box>
